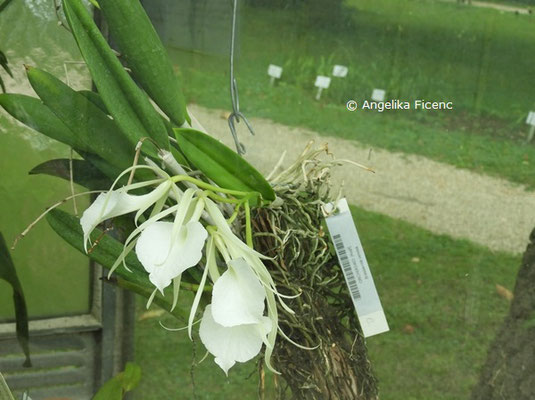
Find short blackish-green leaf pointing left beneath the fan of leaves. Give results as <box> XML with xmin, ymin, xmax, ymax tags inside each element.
<box><xmin>29</xmin><ymin>158</ymin><xmax>112</xmax><ymax>190</ymax></box>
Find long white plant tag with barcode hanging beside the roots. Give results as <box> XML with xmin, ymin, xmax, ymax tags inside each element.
<box><xmin>323</xmin><ymin>199</ymin><xmax>390</xmax><ymax>337</ymax></box>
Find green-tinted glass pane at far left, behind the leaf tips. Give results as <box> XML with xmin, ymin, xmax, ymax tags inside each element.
<box><xmin>0</xmin><ymin>1</ymin><xmax>90</xmax><ymax>320</ymax></box>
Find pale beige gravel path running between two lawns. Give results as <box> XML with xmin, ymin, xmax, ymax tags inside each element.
<box><xmin>190</xmin><ymin>105</ymin><xmax>535</xmax><ymax>253</ymax></box>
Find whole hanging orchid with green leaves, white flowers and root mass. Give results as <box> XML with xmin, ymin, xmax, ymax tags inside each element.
<box><xmin>0</xmin><ymin>0</ymin><xmax>384</xmax><ymax>399</ymax></box>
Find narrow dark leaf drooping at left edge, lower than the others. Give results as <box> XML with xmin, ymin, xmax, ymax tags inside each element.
<box><xmin>0</xmin><ymin>232</ymin><xmax>32</xmax><ymax>367</ymax></box>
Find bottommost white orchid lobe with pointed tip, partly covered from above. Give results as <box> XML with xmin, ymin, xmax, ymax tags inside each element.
<box><xmin>199</xmin><ymin>305</ymin><xmax>272</xmax><ymax>375</ymax></box>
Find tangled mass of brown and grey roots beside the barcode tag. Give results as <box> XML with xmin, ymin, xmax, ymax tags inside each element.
<box><xmin>253</xmin><ymin>143</ymin><xmax>377</xmax><ymax>400</ymax></box>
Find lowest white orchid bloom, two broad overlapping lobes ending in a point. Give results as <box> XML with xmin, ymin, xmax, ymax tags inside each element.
<box><xmin>199</xmin><ymin>259</ymin><xmax>273</xmax><ymax>374</ymax></box>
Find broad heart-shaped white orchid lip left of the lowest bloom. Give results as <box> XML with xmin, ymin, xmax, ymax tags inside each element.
<box><xmin>136</xmin><ymin>221</ymin><xmax>208</xmax><ymax>294</ymax></box>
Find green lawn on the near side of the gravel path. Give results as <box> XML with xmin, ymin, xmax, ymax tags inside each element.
<box><xmin>136</xmin><ymin>207</ymin><xmax>520</xmax><ymax>400</ymax></box>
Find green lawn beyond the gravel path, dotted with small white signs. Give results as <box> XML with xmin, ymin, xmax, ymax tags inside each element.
<box><xmin>171</xmin><ymin>0</ymin><xmax>535</xmax><ymax>187</ymax></box>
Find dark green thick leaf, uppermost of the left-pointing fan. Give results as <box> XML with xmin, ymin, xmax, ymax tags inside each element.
<box><xmin>27</xmin><ymin>67</ymin><xmax>134</xmax><ymax>169</ymax></box>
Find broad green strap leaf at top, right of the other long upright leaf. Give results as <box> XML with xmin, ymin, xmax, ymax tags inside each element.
<box><xmin>99</xmin><ymin>0</ymin><xmax>189</xmax><ymax>126</ymax></box>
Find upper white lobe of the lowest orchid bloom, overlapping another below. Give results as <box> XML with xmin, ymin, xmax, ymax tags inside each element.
<box><xmin>212</xmin><ymin>258</ymin><xmax>266</xmax><ymax>327</ymax></box>
